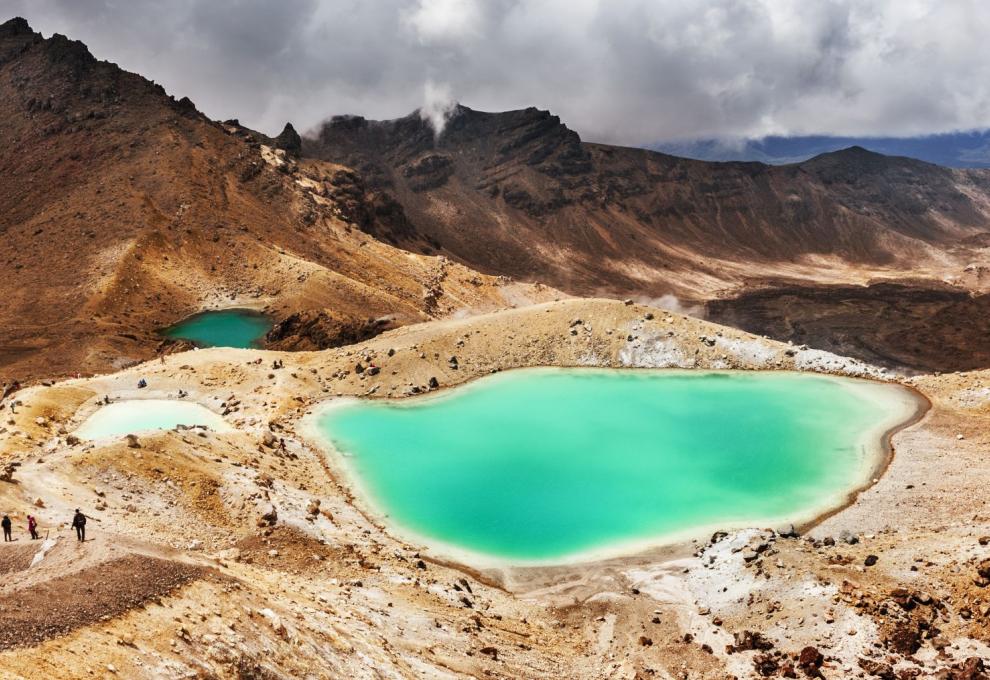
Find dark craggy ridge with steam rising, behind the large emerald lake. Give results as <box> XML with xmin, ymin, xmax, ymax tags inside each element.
<box><xmin>303</xmin><ymin>106</ymin><xmax>990</xmax><ymax>298</ymax></box>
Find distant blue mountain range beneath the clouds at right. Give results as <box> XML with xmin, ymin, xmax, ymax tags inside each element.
<box><xmin>648</xmin><ymin>129</ymin><xmax>990</xmax><ymax>168</ymax></box>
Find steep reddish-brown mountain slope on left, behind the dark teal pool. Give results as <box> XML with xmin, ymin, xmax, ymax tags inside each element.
<box><xmin>0</xmin><ymin>19</ymin><xmax>556</xmax><ymax>381</ymax></box>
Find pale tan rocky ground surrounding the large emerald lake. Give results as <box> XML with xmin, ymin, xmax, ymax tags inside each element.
<box><xmin>0</xmin><ymin>300</ymin><xmax>990</xmax><ymax>680</ymax></box>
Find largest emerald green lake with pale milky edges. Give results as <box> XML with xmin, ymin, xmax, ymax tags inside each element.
<box><xmin>314</xmin><ymin>369</ymin><xmax>916</xmax><ymax>562</ymax></box>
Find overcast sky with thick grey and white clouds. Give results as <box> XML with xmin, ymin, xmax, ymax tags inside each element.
<box><xmin>7</xmin><ymin>0</ymin><xmax>990</xmax><ymax>144</ymax></box>
